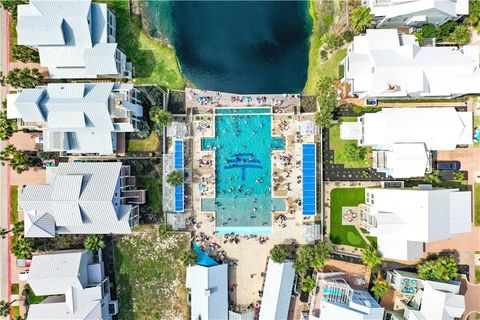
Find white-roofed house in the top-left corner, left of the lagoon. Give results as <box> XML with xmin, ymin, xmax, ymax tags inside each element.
<box><xmin>17</xmin><ymin>0</ymin><xmax>132</xmax><ymax>79</ymax></box>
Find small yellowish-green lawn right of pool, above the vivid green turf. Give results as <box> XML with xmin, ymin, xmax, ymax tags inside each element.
<box><xmin>329</xmin><ymin>117</ymin><xmax>372</xmax><ymax>168</ymax></box>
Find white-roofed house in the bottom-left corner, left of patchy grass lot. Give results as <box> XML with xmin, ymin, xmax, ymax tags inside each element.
<box><xmin>27</xmin><ymin>250</ymin><xmax>118</xmax><ymax>320</ymax></box>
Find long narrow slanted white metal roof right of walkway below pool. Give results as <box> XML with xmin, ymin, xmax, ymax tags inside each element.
<box><xmin>259</xmin><ymin>259</ymin><xmax>295</xmax><ymax>320</ymax></box>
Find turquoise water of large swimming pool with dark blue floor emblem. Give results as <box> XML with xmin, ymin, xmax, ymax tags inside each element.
<box><xmin>202</xmin><ymin>108</ymin><xmax>285</xmax><ymax>234</ymax></box>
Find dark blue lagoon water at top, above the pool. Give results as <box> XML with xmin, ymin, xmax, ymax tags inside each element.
<box><xmin>145</xmin><ymin>0</ymin><xmax>311</xmax><ymax>93</ymax></box>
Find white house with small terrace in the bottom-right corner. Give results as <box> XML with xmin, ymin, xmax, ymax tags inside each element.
<box><xmin>387</xmin><ymin>270</ymin><xmax>465</xmax><ymax>320</ymax></box>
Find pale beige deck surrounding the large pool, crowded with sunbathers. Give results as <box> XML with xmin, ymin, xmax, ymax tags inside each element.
<box><xmin>187</xmin><ymin>89</ymin><xmax>319</xmax><ymax>307</ymax></box>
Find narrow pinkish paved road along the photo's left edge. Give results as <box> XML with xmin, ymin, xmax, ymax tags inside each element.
<box><xmin>0</xmin><ymin>9</ymin><xmax>8</xmax><ymax>308</ymax></box>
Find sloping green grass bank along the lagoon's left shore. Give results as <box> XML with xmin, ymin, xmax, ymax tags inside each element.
<box><xmin>102</xmin><ymin>0</ymin><xmax>185</xmax><ymax>89</ymax></box>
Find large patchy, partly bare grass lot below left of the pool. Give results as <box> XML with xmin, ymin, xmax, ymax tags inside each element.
<box><xmin>115</xmin><ymin>226</ymin><xmax>190</xmax><ymax>320</ymax></box>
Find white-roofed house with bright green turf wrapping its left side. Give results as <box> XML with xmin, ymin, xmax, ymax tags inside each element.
<box><xmin>360</xmin><ymin>185</ymin><xmax>472</xmax><ymax>260</ymax></box>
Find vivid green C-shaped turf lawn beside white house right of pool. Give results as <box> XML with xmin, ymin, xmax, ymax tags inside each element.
<box><xmin>330</xmin><ymin>188</ymin><xmax>373</xmax><ymax>248</ymax></box>
